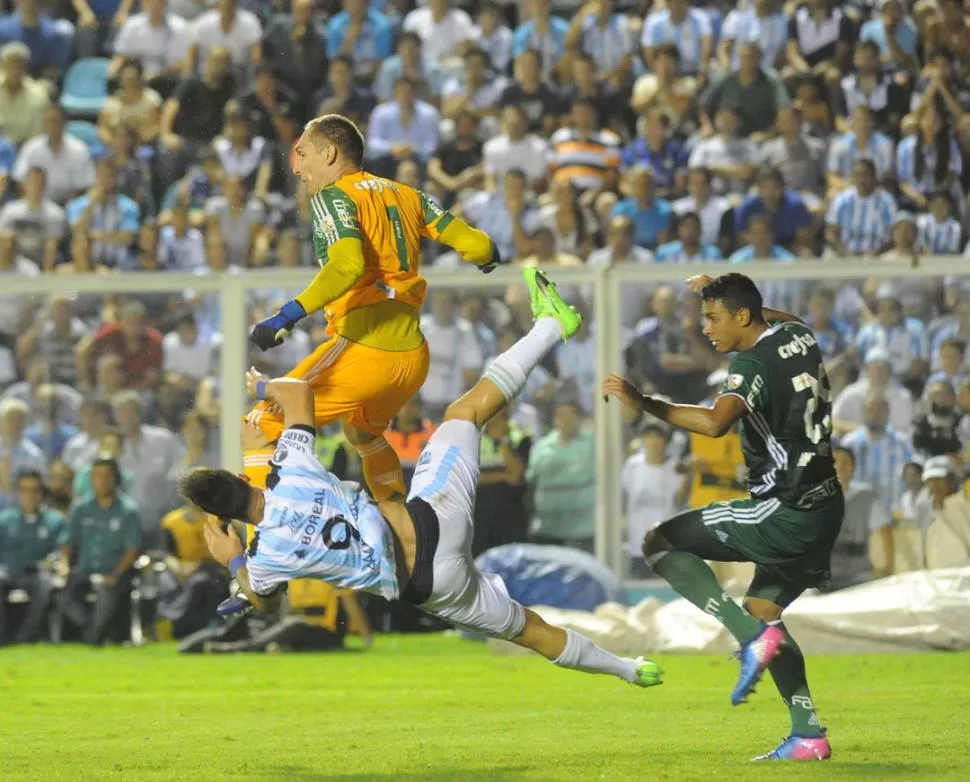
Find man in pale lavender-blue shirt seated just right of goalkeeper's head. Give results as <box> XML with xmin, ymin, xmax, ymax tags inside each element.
<box><xmin>367</xmin><ymin>77</ymin><xmax>439</xmax><ymax>175</ymax></box>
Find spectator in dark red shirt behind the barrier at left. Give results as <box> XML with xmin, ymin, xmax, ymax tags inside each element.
<box><xmin>78</xmin><ymin>301</ymin><xmax>163</xmax><ymax>390</ymax></box>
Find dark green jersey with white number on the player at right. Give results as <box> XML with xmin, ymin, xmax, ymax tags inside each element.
<box><xmin>721</xmin><ymin>322</ymin><xmax>841</xmax><ymax>510</ymax></box>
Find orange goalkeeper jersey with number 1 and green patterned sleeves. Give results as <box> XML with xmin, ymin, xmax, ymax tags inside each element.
<box><xmin>310</xmin><ymin>171</ymin><xmax>453</xmax><ymax>331</ymax></box>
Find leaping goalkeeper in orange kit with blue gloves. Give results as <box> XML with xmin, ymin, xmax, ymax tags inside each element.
<box><xmin>243</xmin><ymin>114</ymin><xmax>501</xmax><ymax>508</ymax></box>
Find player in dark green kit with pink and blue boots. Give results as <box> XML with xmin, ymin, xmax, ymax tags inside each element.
<box><xmin>603</xmin><ymin>274</ymin><xmax>844</xmax><ymax>760</ymax></box>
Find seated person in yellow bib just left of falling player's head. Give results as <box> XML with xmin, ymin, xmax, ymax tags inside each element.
<box><xmin>158</xmin><ymin>505</ymin><xmax>228</xmax><ymax>639</ymax></box>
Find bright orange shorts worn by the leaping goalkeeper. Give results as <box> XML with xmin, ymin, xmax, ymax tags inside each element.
<box><xmin>246</xmin><ymin>336</ymin><xmax>431</xmax><ymax>441</ymax></box>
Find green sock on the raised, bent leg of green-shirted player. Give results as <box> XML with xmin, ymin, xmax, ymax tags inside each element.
<box><xmin>648</xmin><ymin>551</ymin><xmax>761</xmax><ymax>644</ymax></box>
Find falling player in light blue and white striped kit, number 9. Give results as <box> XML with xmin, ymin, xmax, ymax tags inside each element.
<box><xmin>181</xmin><ymin>268</ymin><xmax>662</xmax><ymax>687</ymax></box>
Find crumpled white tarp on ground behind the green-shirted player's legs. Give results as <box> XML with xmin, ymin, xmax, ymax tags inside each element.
<box><xmin>490</xmin><ymin>567</ymin><xmax>970</xmax><ymax>655</ymax></box>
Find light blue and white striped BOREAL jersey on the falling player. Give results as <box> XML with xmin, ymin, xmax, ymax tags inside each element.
<box><xmin>246</xmin><ymin>427</ymin><xmax>399</xmax><ymax>600</ymax></box>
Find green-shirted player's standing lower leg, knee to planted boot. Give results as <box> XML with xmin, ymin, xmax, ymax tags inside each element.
<box><xmin>744</xmin><ymin>566</ymin><xmax>831</xmax><ymax>760</ymax></box>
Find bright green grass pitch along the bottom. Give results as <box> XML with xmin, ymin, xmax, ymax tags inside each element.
<box><xmin>0</xmin><ymin>636</ymin><xmax>970</xmax><ymax>782</ymax></box>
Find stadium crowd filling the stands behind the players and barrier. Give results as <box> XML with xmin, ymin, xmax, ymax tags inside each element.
<box><xmin>0</xmin><ymin>0</ymin><xmax>970</xmax><ymax>643</ymax></box>
